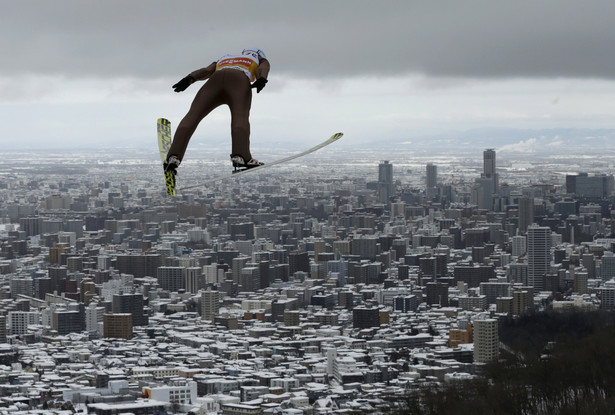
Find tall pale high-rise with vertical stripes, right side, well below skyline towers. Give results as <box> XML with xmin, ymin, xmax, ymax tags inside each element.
<box><xmin>526</xmin><ymin>224</ymin><xmax>551</xmax><ymax>291</ymax></box>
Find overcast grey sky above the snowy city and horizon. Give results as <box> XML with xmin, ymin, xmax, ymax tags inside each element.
<box><xmin>0</xmin><ymin>0</ymin><xmax>615</xmax><ymax>157</ymax></box>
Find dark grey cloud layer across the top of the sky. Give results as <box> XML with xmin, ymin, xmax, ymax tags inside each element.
<box><xmin>0</xmin><ymin>0</ymin><xmax>615</xmax><ymax>79</ymax></box>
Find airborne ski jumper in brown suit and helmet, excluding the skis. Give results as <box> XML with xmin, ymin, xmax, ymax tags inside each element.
<box><xmin>164</xmin><ymin>48</ymin><xmax>270</xmax><ymax>176</ymax></box>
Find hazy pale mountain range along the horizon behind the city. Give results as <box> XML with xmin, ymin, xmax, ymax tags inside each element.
<box><xmin>12</xmin><ymin>128</ymin><xmax>615</xmax><ymax>158</ymax></box>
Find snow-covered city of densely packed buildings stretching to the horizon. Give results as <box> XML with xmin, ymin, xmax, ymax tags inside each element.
<box><xmin>0</xmin><ymin>150</ymin><xmax>615</xmax><ymax>415</ymax></box>
